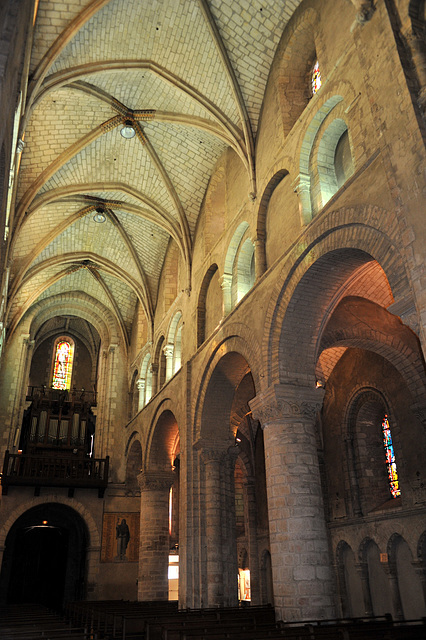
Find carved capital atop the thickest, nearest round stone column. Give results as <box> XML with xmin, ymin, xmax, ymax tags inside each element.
<box><xmin>249</xmin><ymin>384</ymin><xmax>325</xmax><ymax>425</ymax></box>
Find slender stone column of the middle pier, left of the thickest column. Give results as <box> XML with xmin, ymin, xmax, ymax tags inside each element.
<box><xmin>201</xmin><ymin>443</ymin><xmax>238</xmax><ymax>607</ymax></box>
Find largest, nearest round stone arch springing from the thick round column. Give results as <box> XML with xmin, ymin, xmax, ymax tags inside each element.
<box><xmin>264</xmin><ymin>218</ymin><xmax>410</xmax><ymax>385</ymax></box>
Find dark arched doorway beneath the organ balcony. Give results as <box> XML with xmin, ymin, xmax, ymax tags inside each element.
<box><xmin>0</xmin><ymin>503</ymin><xmax>88</xmax><ymax>610</ymax></box>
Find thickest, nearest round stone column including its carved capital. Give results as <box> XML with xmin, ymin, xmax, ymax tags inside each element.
<box><xmin>249</xmin><ymin>384</ymin><xmax>335</xmax><ymax>620</ymax></box>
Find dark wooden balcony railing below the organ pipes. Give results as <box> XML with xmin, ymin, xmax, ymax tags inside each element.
<box><xmin>1</xmin><ymin>451</ymin><xmax>109</xmax><ymax>498</ymax></box>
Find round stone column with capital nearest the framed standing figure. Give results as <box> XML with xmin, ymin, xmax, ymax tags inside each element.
<box><xmin>138</xmin><ymin>471</ymin><xmax>174</xmax><ymax>600</ymax></box>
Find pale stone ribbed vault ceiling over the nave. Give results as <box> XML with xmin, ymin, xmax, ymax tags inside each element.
<box><xmin>8</xmin><ymin>0</ymin><xmax>300</xmax><ymax>350</ymax></box>
